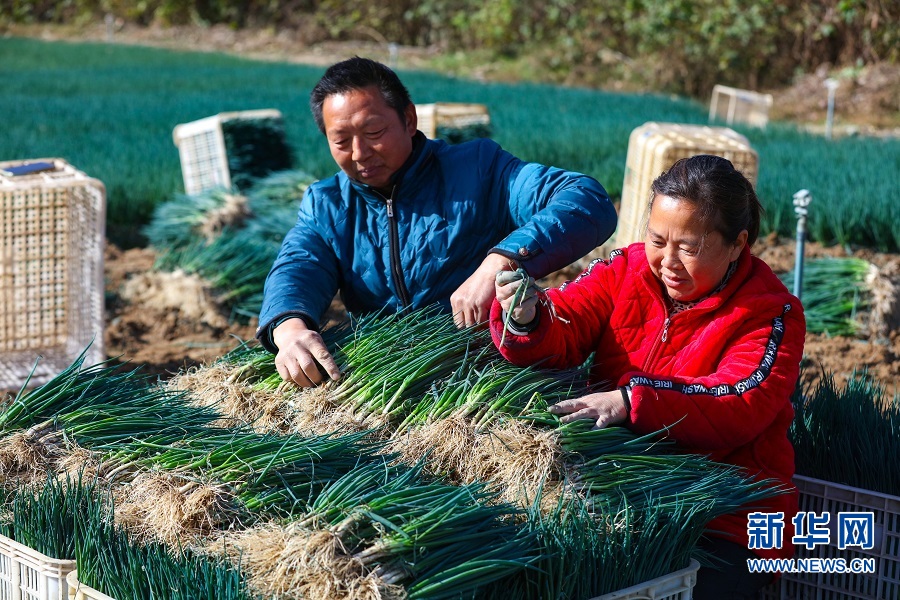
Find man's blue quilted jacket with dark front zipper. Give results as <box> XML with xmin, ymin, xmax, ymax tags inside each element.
<box><xmin>257</xmin><ymin>133</ymin><xmax>616</xmax><ymax>352</ymax></box>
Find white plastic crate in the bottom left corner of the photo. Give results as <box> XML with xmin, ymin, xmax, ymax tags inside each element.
<box><xmin>0</xmin><ymin>535</ymin><xmax>75</xmax><ymax>600</ymax></box>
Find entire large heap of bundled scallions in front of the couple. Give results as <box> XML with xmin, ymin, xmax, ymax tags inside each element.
<box><xmin>0</xmin><ymin>308</ymin><xmax>782</xmax><ymax>600</ymax></box>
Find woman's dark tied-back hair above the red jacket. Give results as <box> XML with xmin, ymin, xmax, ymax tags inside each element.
<box><xmin>650</xmin><ymin>154</ymin><xmax>763</xmax><ymax>246</ymax></box>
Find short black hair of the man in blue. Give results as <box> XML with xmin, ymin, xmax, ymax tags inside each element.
<box><xmin>309</xmin><ymin>56</ymin><xmax>412</xmax><ymax>133</ymax></box>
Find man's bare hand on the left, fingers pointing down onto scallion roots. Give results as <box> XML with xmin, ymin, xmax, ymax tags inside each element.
<box><xmin>272</xmin><ymin>319</ymin><xmax>341</xmax><ymax>387</ymax></box>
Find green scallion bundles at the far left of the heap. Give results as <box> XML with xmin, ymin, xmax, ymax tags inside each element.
<box><xmin>0</xmin><ymin>350</ymin><xmax>390</xmax><ymax>514</ymax></box>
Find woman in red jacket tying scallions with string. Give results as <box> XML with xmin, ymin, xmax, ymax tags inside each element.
<box><xmin>491</xmin><ymin>155</ymin><xmax>806</xmax><ymax>599</ymax></box>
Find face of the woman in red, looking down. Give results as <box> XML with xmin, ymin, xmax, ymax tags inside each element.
<box><xmin>644</xmin><ymin>196</ymin><xmax>747</xmax><ymax>302</ymax></box>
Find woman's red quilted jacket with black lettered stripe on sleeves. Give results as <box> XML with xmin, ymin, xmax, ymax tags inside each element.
<box><xmin>491</xmin><ymin>243</ymin><xmax>806</xmax><ymax>558</ymax></box>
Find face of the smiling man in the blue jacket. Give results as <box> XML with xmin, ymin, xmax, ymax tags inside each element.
<box><xmin>322</xmin><ymin>86</ymin><xmax>417</xmax><ymax>189</ymax></box>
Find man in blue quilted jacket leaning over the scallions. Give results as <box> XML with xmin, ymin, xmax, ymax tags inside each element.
<box><xmin>257</xmin><ymin>57</ymin><xmax>616</xmax><ymax>387</ymax></box>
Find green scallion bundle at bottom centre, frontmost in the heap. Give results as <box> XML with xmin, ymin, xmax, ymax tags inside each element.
<box><xmin>301</xmin><ymin>463</ymin><xmax>537</xmax><ymax>599</ymax></box>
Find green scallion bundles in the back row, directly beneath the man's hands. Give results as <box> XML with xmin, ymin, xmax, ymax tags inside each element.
<box><xmin>222</xmin><ymin>306</ymin><xmax>587</xmax><ymax>433</ymax></box>
